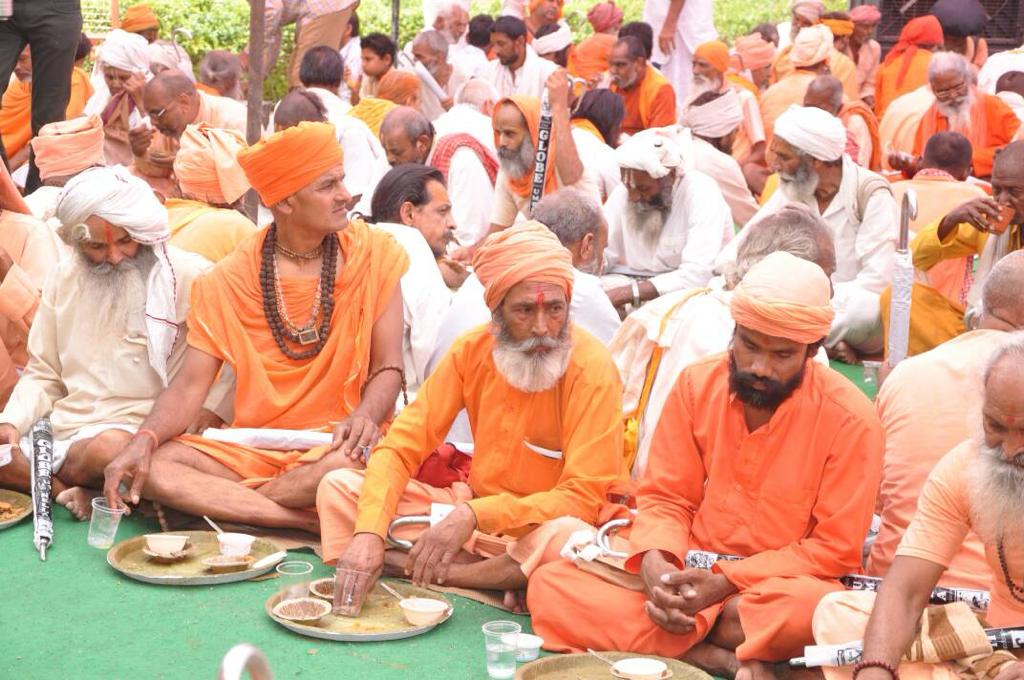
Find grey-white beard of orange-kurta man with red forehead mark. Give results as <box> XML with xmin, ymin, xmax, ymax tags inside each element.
<box><xmin>490</xmin><ymin>312</ymin><xmax>572</xmax><ymax>393</ymax></box>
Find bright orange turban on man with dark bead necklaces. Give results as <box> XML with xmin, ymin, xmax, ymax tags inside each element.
<box><xmin>238</xmin><ymin>121</ymin><xmax>342</xmax><ymax>208</ymax></box>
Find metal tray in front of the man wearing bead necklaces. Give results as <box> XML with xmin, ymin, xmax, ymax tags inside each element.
<box><xmin>106</xmin><ymin>532</ymin><xmax>284</xmax><ymax>586</ymax></box>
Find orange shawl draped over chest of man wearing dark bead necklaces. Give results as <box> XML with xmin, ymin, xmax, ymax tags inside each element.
<box><xmin>188</xmin><ymin>220</ymin><xmax>409</xmax><ymax>429</ymax></box>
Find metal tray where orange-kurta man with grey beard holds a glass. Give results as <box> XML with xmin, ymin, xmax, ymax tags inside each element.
<box><xmin>264</xmin><ymin>580</ymin><xmax>452</xmax><ymax>642</ymax></box>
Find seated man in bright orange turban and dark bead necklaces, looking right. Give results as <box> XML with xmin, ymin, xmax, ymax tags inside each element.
<box><xmin>104</xmin><ymin>123</ymin><xmax>409</xmax><ymax>534</ymax></box>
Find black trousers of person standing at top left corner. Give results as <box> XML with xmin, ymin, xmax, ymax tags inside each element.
<box><xmin>0</xmin><ymin>0</ymin><xmax>82</xmax><ymax>193</ymax></box>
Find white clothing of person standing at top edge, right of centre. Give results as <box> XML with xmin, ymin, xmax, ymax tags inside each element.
<box><xmin>643</xmin><ymin>0</ymin><xmax>718</xmax><ymax>106</ymax></box>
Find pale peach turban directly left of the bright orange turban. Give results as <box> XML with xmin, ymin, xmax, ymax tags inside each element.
<box><xmin>174</xmin><ymin>125</ymin><xmax>249</xmax><ymax>205</ymax></box>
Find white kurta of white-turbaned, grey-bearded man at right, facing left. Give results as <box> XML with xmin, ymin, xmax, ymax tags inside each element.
<box><xmin>716</xmin><ymin>156</ymin><xmax>899</xmax><ymax>352</ymax></box>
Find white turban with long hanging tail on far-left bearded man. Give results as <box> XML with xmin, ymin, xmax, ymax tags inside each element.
<box><xmin>56</xmin><ymin>166</ymin><xmax>178</xmax><ymax>386</ymax></box>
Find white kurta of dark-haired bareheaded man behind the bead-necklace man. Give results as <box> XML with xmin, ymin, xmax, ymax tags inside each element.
<box><xmin>373</xmin><ymin>222</ymin><xmax>452</xmax><ymax>398</ymax></box>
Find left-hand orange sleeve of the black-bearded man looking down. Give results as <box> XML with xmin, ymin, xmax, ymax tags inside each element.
<box><xmin>626</xmin><ymin>371</ymin><xmax>708</xmax><ymax>573</ymax></box>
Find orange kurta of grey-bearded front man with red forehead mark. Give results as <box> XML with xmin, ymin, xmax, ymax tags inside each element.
<box><xmin>317</xmin><ymin>326</ymin><xmax>626</xmax><ymax>559</ymax></box>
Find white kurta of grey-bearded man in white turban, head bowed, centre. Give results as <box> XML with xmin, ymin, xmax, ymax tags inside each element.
<box><xmin>604</xmin><ymin>170</ymin><xmax>732</xmax><ymax>295</ymax></box>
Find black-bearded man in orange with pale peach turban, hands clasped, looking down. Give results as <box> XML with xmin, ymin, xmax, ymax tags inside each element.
<box><xmin>527</xmin><ymin>251</ymin><xmax>883</xmax><ymax>678</ymax></box>
